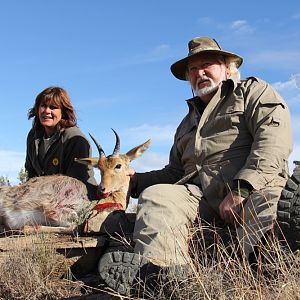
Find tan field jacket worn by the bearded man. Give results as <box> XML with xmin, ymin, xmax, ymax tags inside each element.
<box><xmin>136</xmin><ymin>77</ymin><xmax>292</xmax><ymax>208</ymax></box>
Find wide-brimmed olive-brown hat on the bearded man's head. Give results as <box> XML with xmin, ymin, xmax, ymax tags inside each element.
<box><xmin>171</xmin><ymin>37</ymin><xmax>243</xmax><ymax>80</ymax></box>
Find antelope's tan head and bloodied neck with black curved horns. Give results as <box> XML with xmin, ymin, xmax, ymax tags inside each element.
<box><xmin>76</xmin><ymin>129</ymin><xmax>151</xmax><ymax>232</ymax></box>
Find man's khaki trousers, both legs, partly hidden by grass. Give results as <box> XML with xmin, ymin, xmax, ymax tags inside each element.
<box><xmin>133</xmin><ymin>184</ymin><xmax>282</xmax><ymax>266</ymax></box>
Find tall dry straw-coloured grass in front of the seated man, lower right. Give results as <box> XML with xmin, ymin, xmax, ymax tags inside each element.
<box><xmin>139</xmin><ymin>228</ymin><xmax>300</xmax><ymax>300</ymax></box>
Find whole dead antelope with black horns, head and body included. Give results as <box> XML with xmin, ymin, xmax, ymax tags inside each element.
<box><xmin>0</xmin><ymin>131</ymin><xmax>150</xmax><ymax>233</ymax></box>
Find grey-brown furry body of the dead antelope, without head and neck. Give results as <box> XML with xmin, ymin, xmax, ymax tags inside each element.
<box><xmin>0</xmin><ymin>175</ymin><xmax>90</xmax><ymax>230</ymax></box>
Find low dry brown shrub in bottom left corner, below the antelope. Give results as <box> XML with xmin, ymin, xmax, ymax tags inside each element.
<box><xmin>0</xmin><ymin>236</ymin><xmax>80</xmax><ymax>300</ymax></box>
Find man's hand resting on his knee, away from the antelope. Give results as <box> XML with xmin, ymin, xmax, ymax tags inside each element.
<box><xmin>219</xmin><ymin>192</ymin><xmax>245</xmax><ymax>224</ymax></box>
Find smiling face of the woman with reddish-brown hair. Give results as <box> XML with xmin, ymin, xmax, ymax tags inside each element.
<box><xmin>39</xmin><ymin>102</ymin><xmax>62</xmax><ymax>137</ymax></box>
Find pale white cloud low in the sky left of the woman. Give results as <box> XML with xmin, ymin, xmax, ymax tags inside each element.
<box><xmin>0</xmin><ymin>150</ymin><xmax>25</xmax><ymax>184</ymax></box>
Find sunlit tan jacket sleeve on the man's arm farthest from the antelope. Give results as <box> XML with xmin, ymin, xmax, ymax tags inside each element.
<box><xmin>235</xmin><ymin>78</ymin><xmax>292</xmax><ymax>190</ymax></box>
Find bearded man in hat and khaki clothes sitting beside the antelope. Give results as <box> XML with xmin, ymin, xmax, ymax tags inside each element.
<box><xmin>99</xmin><ymin>37</ymin><xmax>292</xmax><ymax>294</ymax></box>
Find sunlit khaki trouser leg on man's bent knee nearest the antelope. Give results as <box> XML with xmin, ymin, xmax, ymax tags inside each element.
<box><xmin>133</xmin><ymin>184</ymin><xmax>200</xmax><ymax>266</ymax></box>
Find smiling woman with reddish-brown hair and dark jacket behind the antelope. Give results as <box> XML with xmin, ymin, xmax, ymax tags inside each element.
<box><xmin>25</xmin><ymin>87</ymin><xmax>97</xmax><ymax>199</ymax></box>
